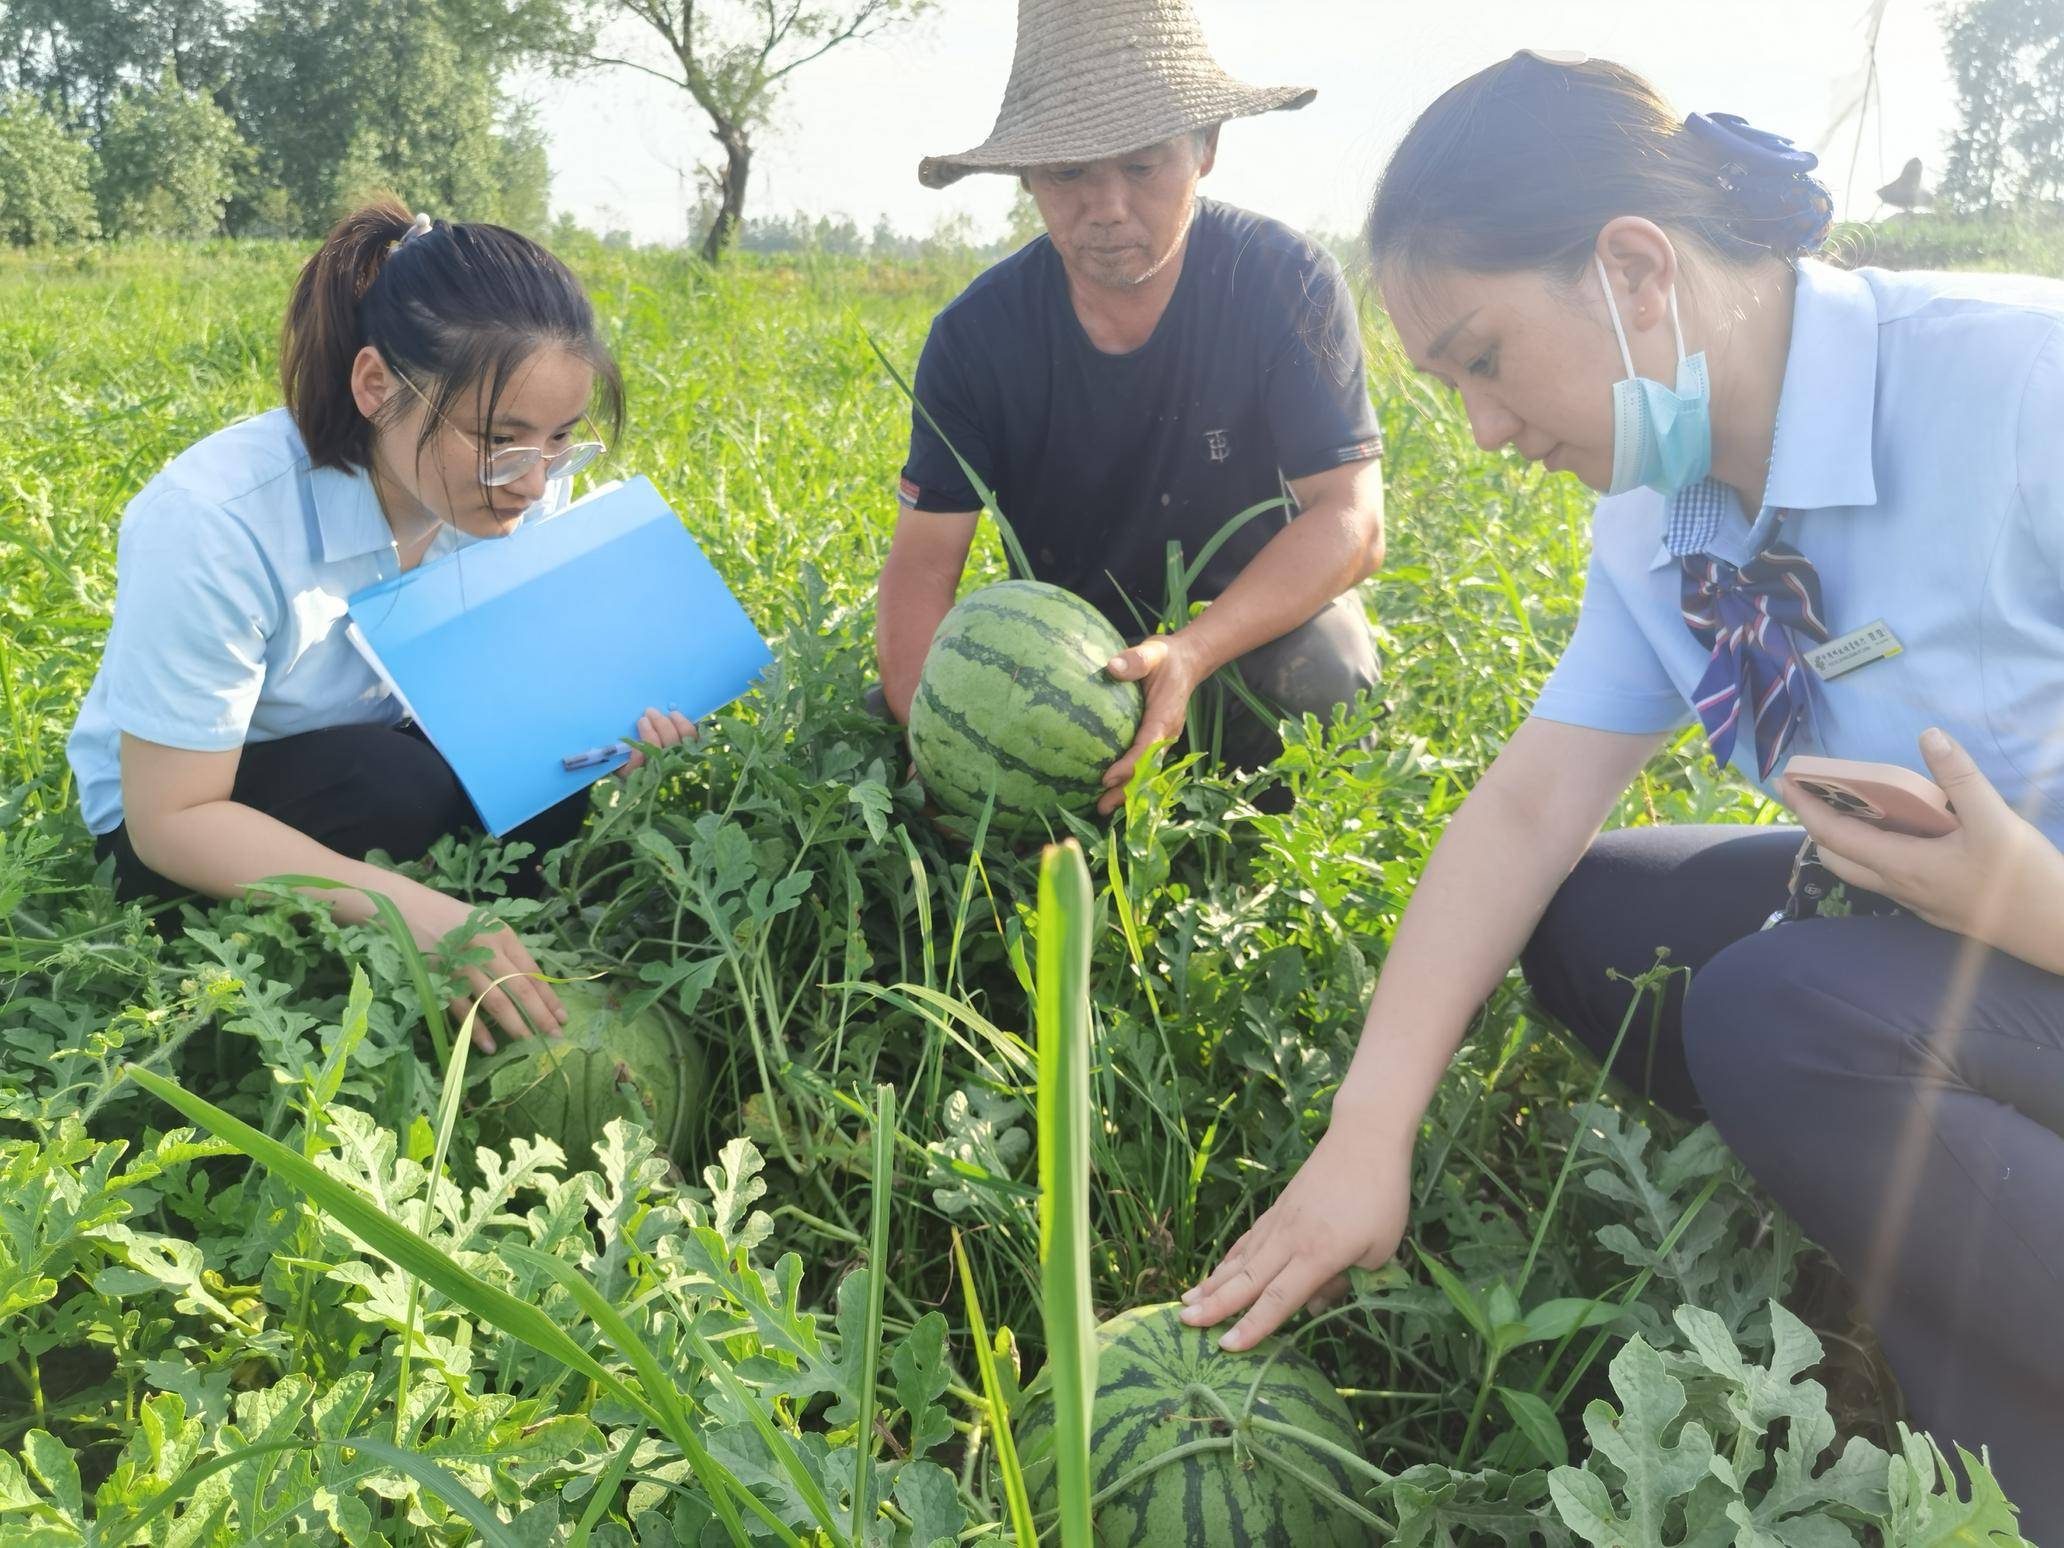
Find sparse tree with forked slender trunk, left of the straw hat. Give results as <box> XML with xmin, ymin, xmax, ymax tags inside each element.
<box><xmin>559</xmin><ymin>0</ymin><xmax>935</xmax><ymax>262</ymax></box>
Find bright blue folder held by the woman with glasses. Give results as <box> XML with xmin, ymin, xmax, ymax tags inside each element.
<box><xmin>349</xmin><ymin>477</ymin><xmax>774</xmax><ymax>836</ymax></box>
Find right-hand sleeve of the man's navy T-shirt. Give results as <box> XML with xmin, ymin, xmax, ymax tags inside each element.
<box><xmin>1263</xmin><ymin>248</ymin><xmax>1383</xmax><ymax>479</ymax></box>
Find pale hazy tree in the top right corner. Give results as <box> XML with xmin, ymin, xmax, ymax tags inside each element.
<box><xmin>1942</xmin><ymin>0</ymin><xmax>2064</xmax><ymax>213</ymax></box>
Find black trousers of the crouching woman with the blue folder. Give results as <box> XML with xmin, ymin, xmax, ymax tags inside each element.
<box><xmin>93</xmin><ymin>722</ymin><xmax>588</xmax><ymax>902</ymax></box>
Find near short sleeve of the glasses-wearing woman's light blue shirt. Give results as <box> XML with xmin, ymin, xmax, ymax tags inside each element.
<box><xmin>101</xmin><ymin>489</ymin><xmax>285</xmax><ymax>751</ymax></box>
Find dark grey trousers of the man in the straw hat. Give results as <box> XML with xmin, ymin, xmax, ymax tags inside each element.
<box><xmin>867</xmin><ymin>588</ymin><xmax>1383</xmax><ymax>768</ymax></box>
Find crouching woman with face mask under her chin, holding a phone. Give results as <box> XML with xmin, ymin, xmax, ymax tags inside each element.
<box><xmin>1185</xmin><ymin>54</ymin><xmax>2064</xmax><ymax>1542</ymax></box>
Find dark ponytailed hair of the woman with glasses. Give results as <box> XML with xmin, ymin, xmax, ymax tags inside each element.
<box><xmin>279</xmin><ymin>198</ymin><xmax>623</xmax><ymax>471</ymax></box>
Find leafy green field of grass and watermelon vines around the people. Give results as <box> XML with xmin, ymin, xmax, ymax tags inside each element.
<box><xmin>0</xmin><ymin>246</ymin><xmax>2030</xmax><ymax>1548</ymax></box>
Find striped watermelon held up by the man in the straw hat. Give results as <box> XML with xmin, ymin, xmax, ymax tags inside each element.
<box><xmin>910</xmin><ymin>580</ymin><xmax>1143</xmax><ymax>834</ymax></box>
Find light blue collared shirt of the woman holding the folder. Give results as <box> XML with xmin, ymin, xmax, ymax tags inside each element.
<box><xmin>66</xmin><ymin>409</ymin><xmax>572</xmax><ymax>834</ymax></box>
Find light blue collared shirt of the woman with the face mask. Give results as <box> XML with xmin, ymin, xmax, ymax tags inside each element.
<box><xmin>1534</xmin><ymin>262</ymin><xmax>2064</xmax><ymax>844</ymax></box>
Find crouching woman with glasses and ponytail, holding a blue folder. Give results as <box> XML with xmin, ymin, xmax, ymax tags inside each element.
<box><xmin>68</xmin><ymin>200</ymin><xmax>691</xmax><ymax>1049</ymax></box>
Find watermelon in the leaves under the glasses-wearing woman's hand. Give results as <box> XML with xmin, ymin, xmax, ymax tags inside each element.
<box><xmin>469</xmin><ymin>978</ymin><xmax>706</xmax><ymax>1168</ymax></box>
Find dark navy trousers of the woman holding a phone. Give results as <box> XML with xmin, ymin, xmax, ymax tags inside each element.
<box><xmin>1521</xmin><ymin>828</ymin><xmax>2064</xmax><ymax>1544</ymax></box>
